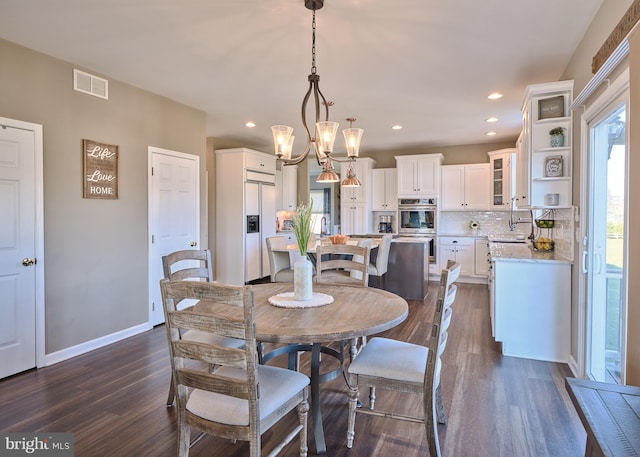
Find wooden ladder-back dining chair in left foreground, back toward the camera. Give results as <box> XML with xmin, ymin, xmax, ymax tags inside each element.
<box><xmin>160</xmin><ymin>279</ymin><xmax>309</xmax><ymax>457</ymax></box>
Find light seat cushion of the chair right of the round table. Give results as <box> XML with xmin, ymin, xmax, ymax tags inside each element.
<box><xmin>348</xmin><ymin>338</ymin><xmax>429</xmax><ymax>383</ymax></box>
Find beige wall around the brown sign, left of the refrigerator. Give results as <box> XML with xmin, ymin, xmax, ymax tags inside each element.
<box><xmin>0</xmin><ymin>40</ymin><xmax>207</xmax><ymax>354</ymax></box>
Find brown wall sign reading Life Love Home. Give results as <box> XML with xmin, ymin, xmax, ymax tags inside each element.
<box><xmin>82</xmin><ymin>140</ymin><xmax>118</xmax><ymax>200</ymax></box>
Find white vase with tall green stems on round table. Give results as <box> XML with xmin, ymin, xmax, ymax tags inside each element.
<box><xmin>291</xmin><ymin>200</ymin><xmax>313</xmax><ymax>301</ymax></box>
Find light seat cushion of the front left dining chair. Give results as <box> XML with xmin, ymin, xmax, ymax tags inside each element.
<box><xmin>187</xmin><ymin>365</ymin><xmax>309</xmax><ymax>425</ymax></box>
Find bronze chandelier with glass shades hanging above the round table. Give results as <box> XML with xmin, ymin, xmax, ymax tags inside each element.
<box><xmin>271</xmin><ymin>0</ymin><xmax>364</xmax><ymax>187</ymax></box>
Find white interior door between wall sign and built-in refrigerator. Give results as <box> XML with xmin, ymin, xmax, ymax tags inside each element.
<box><xmin>149</xmin><ymin>147</ymin><xmax>202</xmax><ymax>325</ymax></box>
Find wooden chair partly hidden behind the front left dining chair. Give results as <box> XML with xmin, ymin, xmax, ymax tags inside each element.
<box><xmin>162</xmin><ymin>249</ymin><xmax>244</xmax><ymax>406</ymax></box>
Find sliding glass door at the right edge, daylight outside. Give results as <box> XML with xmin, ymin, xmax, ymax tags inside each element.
<box><xmin>586</xmin><ymin>98</ymin><xmax>628</xmax><ymax>384</ymax></box>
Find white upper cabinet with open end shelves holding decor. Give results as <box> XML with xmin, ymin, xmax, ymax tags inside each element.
<box><xmin>517</xmin><ymin>81</ymin><xmax>573</xmax><ymax>208</ymax></box>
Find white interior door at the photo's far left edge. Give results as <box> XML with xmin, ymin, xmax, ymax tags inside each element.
<box><xmin>0</xmin><ymin>119</ymin><xmax>43</xmax><ymax>378</ymax></box>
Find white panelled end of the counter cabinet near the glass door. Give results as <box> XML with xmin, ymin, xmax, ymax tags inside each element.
<box><xmin>492</xmin><ymin>260</ymin><xmax>571</xmax><ymax>363</ymax></box>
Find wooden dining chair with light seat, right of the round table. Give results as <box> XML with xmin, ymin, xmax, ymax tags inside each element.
<box><xmin>347</xmin><ymin>261</ymin><xmax>460</xmax><ymax>457</ymax></box>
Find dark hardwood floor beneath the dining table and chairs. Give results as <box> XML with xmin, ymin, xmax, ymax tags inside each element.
<box><xmin>0</xmin><ymin>284</ymin><xmax>586</xmax><ymax>457</ymax></box>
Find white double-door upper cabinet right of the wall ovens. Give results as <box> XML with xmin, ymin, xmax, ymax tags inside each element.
<box><xmin>439</xmin><ymin>163</ymin><xmax>489</xmax><ymax>211</ymax></box>
